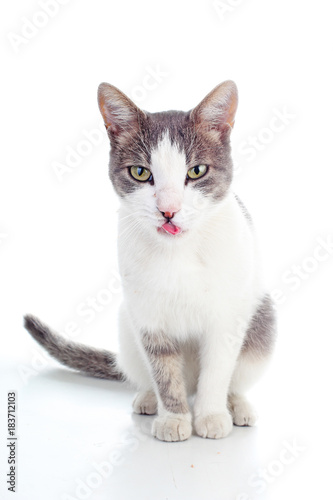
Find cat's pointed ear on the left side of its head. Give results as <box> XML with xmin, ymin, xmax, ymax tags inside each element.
<box><xmin>98</xmin><ymin>83</ymin><xmax>145</xmax><ymax>135</ymax></box>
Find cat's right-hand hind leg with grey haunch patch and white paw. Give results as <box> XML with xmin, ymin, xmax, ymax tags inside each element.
<box><xmin>228</xmin><ymin>295</ymin><xmax>276</xmax><ymax>426</ymax></box>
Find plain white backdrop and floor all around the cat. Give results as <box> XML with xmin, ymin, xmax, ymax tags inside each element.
<box><xmin>0</xmin><ymin>0</ymin><xmax>333</xmax><ymax>500</ymax></box>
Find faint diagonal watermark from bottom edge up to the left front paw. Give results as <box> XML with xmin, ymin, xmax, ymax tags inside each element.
<box><xmin>61</xmin><ymin>426</ymin><xmax>150</xmax><ymax>500</ymax></box>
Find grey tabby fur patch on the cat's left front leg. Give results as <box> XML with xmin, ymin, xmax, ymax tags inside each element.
<box><xmin>142</xmin><ymin>332</ymin><xmax>189</xmax><ymax>413</ymax></box>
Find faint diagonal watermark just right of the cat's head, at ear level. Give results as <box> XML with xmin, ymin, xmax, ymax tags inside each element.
<box><xmin>234</xmin><ymin>106</ymin><xmax>296</xmax><ymax>175</ymax></box>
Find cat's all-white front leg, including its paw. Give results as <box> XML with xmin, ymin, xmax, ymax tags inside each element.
<box><xmin>194</xmin><ymin>325</ymin><xmax>243</xmax><ymax>439</ymax></box>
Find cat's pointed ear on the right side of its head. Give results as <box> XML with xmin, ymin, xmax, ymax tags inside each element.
<box><xmin>191</xmin><ymin>80</ymin><xmax>238</xmax><ymax>133</ymax></box>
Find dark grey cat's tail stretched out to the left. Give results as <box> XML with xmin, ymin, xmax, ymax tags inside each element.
<box><xmin>24</xmin><ymin>314</ymin><xmax>125</xmax><ymax>380</ymax></box>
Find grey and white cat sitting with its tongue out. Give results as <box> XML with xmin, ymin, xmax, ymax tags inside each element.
<box><xmin>25</xmin><ymin>81</ymin><xmax>276</xmax><ymax>441</ymax></box>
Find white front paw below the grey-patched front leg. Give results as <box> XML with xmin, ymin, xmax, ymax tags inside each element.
<box><xmin>152</xmin><ymin>414</ymin><xmax>192</xmax><ymax>441</ymax></box>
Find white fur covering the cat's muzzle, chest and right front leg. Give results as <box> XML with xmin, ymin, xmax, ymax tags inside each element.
<box><xmin>115</xmin><ymin>135</ymin><xmax>264</xmax><ymax>439</ymax></box>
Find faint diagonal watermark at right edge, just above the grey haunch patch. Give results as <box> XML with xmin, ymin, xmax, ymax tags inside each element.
<box><xmin>271</xmin><ymin>234</ymin><xmax>333</xmax><ymax>305</ymax></box>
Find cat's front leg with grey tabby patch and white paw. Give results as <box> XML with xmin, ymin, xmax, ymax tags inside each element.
<box><xmin>141</xmin><ymin>332</ymin><xmax>192</xmax><ymax>441</ymax></box>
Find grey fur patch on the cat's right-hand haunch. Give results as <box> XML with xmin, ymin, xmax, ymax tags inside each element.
<box><xmin>242</xmin><ymin>294</ymin><xmax>276</xmax><ymax>358</ymax></box>
